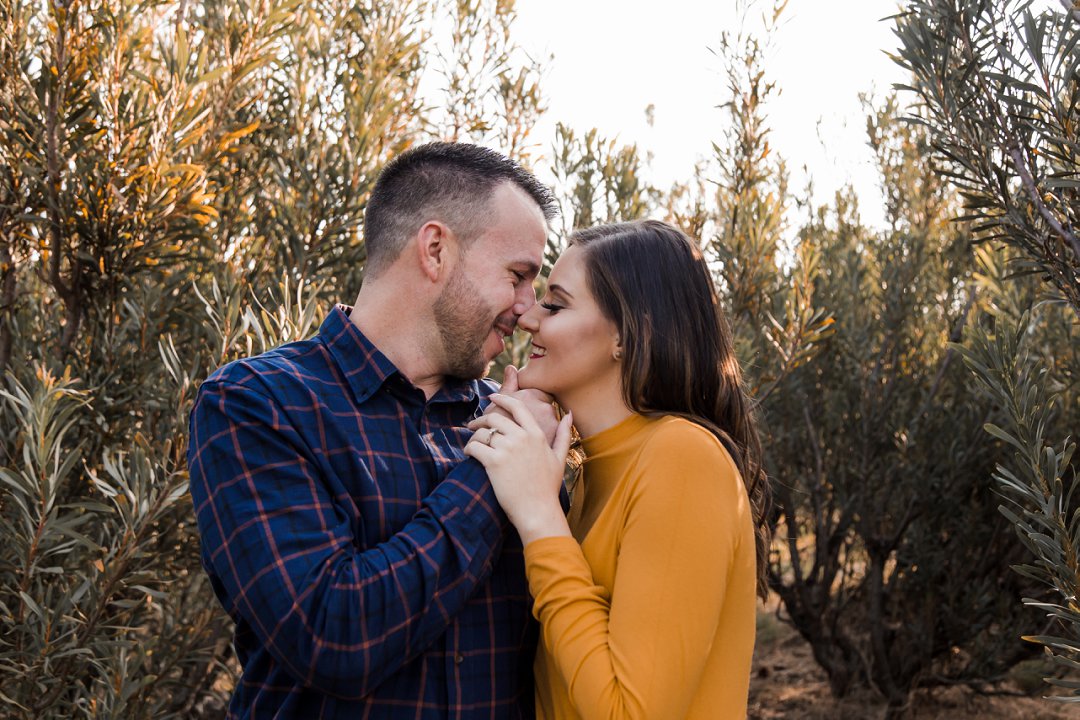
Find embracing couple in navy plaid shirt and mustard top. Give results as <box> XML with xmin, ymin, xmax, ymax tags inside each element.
<box><xmin>189</xmin><ymin>142</ymin><xmax>768</xmax><ymax>720</ymax></box>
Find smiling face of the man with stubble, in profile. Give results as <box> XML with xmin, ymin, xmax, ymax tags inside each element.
<box><xmin>434</xmin><ymin>182</ymin><xmax>546</xmax><ymax>378</ymax></box>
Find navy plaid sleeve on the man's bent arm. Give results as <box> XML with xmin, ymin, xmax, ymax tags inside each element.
<box><xmin>188</xmin><ymin>381</ymin><xmax>505</xmax><ymax>698</ymax></box>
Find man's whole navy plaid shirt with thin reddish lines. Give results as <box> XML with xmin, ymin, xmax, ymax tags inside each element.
<box><xmin>188</xmin><ymin>305</ymin><xmax>536</xmax><ymax>719</ymax></box>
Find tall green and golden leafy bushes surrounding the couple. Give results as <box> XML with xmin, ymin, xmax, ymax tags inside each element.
<box><xmin>0</xmin><ymin>0</ymin><xmax>1080</xmax><ymax>718</ymax></box>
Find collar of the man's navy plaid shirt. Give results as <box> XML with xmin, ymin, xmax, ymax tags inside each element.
<box><xmin>319</xmin><ymin>304</ymin><xmax>480</xmax><ymax>403</ymax></box>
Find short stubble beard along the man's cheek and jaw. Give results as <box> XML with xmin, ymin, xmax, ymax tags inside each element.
<box><xmin>433</xmin><ymin>267</ymin><xmax>494</xmax><ymax>380</ymax></box>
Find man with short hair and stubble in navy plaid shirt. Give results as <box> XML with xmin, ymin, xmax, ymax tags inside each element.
<box><xmin>189</xmin><ymin>144</ymin><xmax>555</xmax><ymax>718</ymax></box>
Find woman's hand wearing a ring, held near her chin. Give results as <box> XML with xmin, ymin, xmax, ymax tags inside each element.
<box><xmin>465</xmin><ymin>394</ymin><xmax>573</xmax><ymax>545</ymax></box>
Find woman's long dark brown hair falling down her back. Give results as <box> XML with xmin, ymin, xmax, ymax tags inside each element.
<box><xmin>570</xmin><ymin>220</ymin><xmax>771</xmax><ymax>598</ymax></box>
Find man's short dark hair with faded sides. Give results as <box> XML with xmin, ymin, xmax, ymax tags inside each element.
<box><xmin>364</xmin><ymin>142</ymin><xmax>558</xmax><ymax>277</ymax></box>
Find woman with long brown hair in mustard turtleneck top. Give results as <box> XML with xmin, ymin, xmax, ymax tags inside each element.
<box><xmin>465</xmin><ymin>220</ymin><xmax>769</xmax><ymax>719</ymax></box>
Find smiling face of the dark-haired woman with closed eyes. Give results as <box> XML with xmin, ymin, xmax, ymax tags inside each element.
<box><xmin>517</xmin><ymin>245</ymin><xmax>620</xmax><ymax>409</ymax></box>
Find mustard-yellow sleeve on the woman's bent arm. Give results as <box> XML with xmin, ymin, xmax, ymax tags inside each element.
<box><xmin>525</xmin><ymin>427</ymin><xmax>745</xmax><ymax>720</ymax></box>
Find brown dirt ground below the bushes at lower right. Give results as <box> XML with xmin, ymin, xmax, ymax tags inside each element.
<box><xmin>747</xmin><ymin>609</ymin><xmax>1080</xmax><ymax>720</ymax></box>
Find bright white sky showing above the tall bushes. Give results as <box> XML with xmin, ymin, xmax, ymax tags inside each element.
<box><xmin>513</xmin><ymin>0</ymin><xmax>905</xmax><ymax>226</ymax></box>
